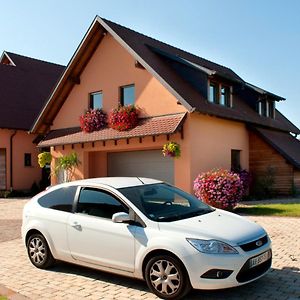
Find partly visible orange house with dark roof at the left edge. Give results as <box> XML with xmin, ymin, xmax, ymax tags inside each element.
<box><xmin>0</xmin><ymin>52</ymin><xmax>64</xmax><ymax>190</ymax></box>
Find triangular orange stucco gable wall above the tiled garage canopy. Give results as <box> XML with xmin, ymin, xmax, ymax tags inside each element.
<box><xmin>51</xmin><ymin>34</ymin><xmax>186</xmax><ymax>129</ymax></box>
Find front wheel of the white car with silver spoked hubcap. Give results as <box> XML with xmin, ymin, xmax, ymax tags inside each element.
<box><xmin>145</xmin><ymin>255</ymin><xmax>191</xmax><ymax>299</ymax></box>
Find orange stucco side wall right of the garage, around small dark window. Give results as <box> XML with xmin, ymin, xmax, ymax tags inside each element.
<box><xmin>187</xmin><ymin>113</ymin><xmax>249</xmax><ymax>189</ymax></box>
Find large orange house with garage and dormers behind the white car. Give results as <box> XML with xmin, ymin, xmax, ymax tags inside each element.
<box><xmin>32</xmin><ymin>17</ymin><xmax>300</xmax><ymax>193</ymax></box>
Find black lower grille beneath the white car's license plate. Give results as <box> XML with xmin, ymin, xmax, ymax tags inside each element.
<box><xmin>236</xmin><ymin>252</ymin><xmax>272</xmax><ymax>283</ymax></box>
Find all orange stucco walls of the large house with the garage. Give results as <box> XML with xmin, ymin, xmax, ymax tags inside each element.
<box><xmin>51</xmin><ymin>34</ymin><xmax>249</xmax><ymax>192</ymax></box>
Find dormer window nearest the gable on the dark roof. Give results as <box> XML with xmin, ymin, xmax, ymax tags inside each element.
<box><xmin>208</xmin><ymin>81</ymin><xmax>232</xmax><ymax>107</ymax></box>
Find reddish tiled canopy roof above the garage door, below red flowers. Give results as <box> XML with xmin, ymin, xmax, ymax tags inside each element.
<box><xmin>38</xmin><ymin>113</ymin><xmax>186</xmax><ymax>147</ymax></box>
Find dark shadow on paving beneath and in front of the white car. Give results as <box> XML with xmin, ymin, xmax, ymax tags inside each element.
<box><xmin>49</xmin><ymin>262</ymin><xmax>300</xmax><ymax>300</ymax></box>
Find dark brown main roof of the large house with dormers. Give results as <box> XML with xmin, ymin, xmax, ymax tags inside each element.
<box><xmin>32</xmin><ymin>16</ymin><xmax>300</xmax><ymax>134</ymax></box>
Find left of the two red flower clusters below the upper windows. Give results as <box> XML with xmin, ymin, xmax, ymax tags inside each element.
<box><xmin>79</xmin><ymin>108</ymin><xmax>107</xmax><ymax>133</ymax></box>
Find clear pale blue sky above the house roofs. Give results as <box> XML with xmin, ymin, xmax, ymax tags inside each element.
<box><xmin>0</xmin><ymin>0</ymin><xmax>300</xmax><ymax>128</ymax></box>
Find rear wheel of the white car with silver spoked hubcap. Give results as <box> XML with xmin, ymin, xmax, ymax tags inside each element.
<box><xmin>27</xmin><ymin>233</ymin><xmax>55</xmax><ymax>269</ymax></box>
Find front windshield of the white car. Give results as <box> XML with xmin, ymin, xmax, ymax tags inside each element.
<box><xmin>119</xmin><ymin>183</ymin><xmax>214</xmax><ymax>222</ymax></box>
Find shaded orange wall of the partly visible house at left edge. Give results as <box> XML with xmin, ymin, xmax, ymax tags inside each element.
<box><xmin>0</xmin><ymin>129</ymin><xmax>42</xmax><ymax>190</ymax></box>
